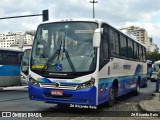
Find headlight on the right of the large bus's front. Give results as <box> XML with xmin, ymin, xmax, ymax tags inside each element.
<box><xmin>77</xmin><ymin>77</ymin><xmax>95</xmax><ymax>89</ymax></box>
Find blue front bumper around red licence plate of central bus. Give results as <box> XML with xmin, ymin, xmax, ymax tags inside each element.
<box><xmin>28</xmin><ymin>83</ymin><xmax>96</xmax><ymax>105</ymax></box>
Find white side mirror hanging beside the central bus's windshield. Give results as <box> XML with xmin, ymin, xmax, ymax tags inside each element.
<box><xmin>93</xmin><ymin>28</ymin><xmax>103</xmax><ymax>48</ymax></box>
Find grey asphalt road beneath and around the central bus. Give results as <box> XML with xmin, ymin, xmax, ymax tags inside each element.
<box><xmin>0</xmin><ymin>81</ymin><xmax>158</xmax><ymax>120</ymax></box>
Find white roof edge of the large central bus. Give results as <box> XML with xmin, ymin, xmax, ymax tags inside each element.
<box><xmin>41</xmin><ymin>18</ymin><xmax>145</xmax><ymax>47</ymax></box>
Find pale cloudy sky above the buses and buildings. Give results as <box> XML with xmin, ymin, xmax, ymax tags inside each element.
<box><xmin>0</xmin><ymin>0</ymin><xmax>160</xmax><ymax>48</ymax></box>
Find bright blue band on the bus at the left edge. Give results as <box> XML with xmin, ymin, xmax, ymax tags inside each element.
<box><xmin>0</xmin><ymin>65</ymin><xmax>20</xmax><ymax>76</ymax></box>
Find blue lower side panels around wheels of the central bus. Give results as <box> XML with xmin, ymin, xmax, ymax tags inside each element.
<box><xmin>98</xmin><ymin>74</ymin><xmax>147</xmax><ymax>104</ymax></box>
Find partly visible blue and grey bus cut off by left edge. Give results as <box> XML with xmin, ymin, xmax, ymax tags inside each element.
<box><xmin>0</xmin><ymin>48</ymin><xmax>23</xmax><ymax>87</ymax></box>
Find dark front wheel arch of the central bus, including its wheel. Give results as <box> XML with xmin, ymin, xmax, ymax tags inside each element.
<box><xmin>107</xmin><ymin>79</ymin><xmax>118</xmax><ymax>106</ymax></box>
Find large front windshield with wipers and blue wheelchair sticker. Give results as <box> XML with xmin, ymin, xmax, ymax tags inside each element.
<box><xmin>31</xmin><ymin>22</ymin><xmax>98</xmax><ymax>73</ymax></box>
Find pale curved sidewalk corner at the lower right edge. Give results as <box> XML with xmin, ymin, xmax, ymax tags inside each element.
<box><xmin>139</xmin><ymin>93</ymin><xmax>160</xmax><ymax>113</ymax></box>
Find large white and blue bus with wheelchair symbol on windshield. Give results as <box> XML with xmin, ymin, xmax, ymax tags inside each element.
<box><xmin>28</xmin><ymin>19</ymin><xmax>147</xmax><ymax>105</ymax></box>
